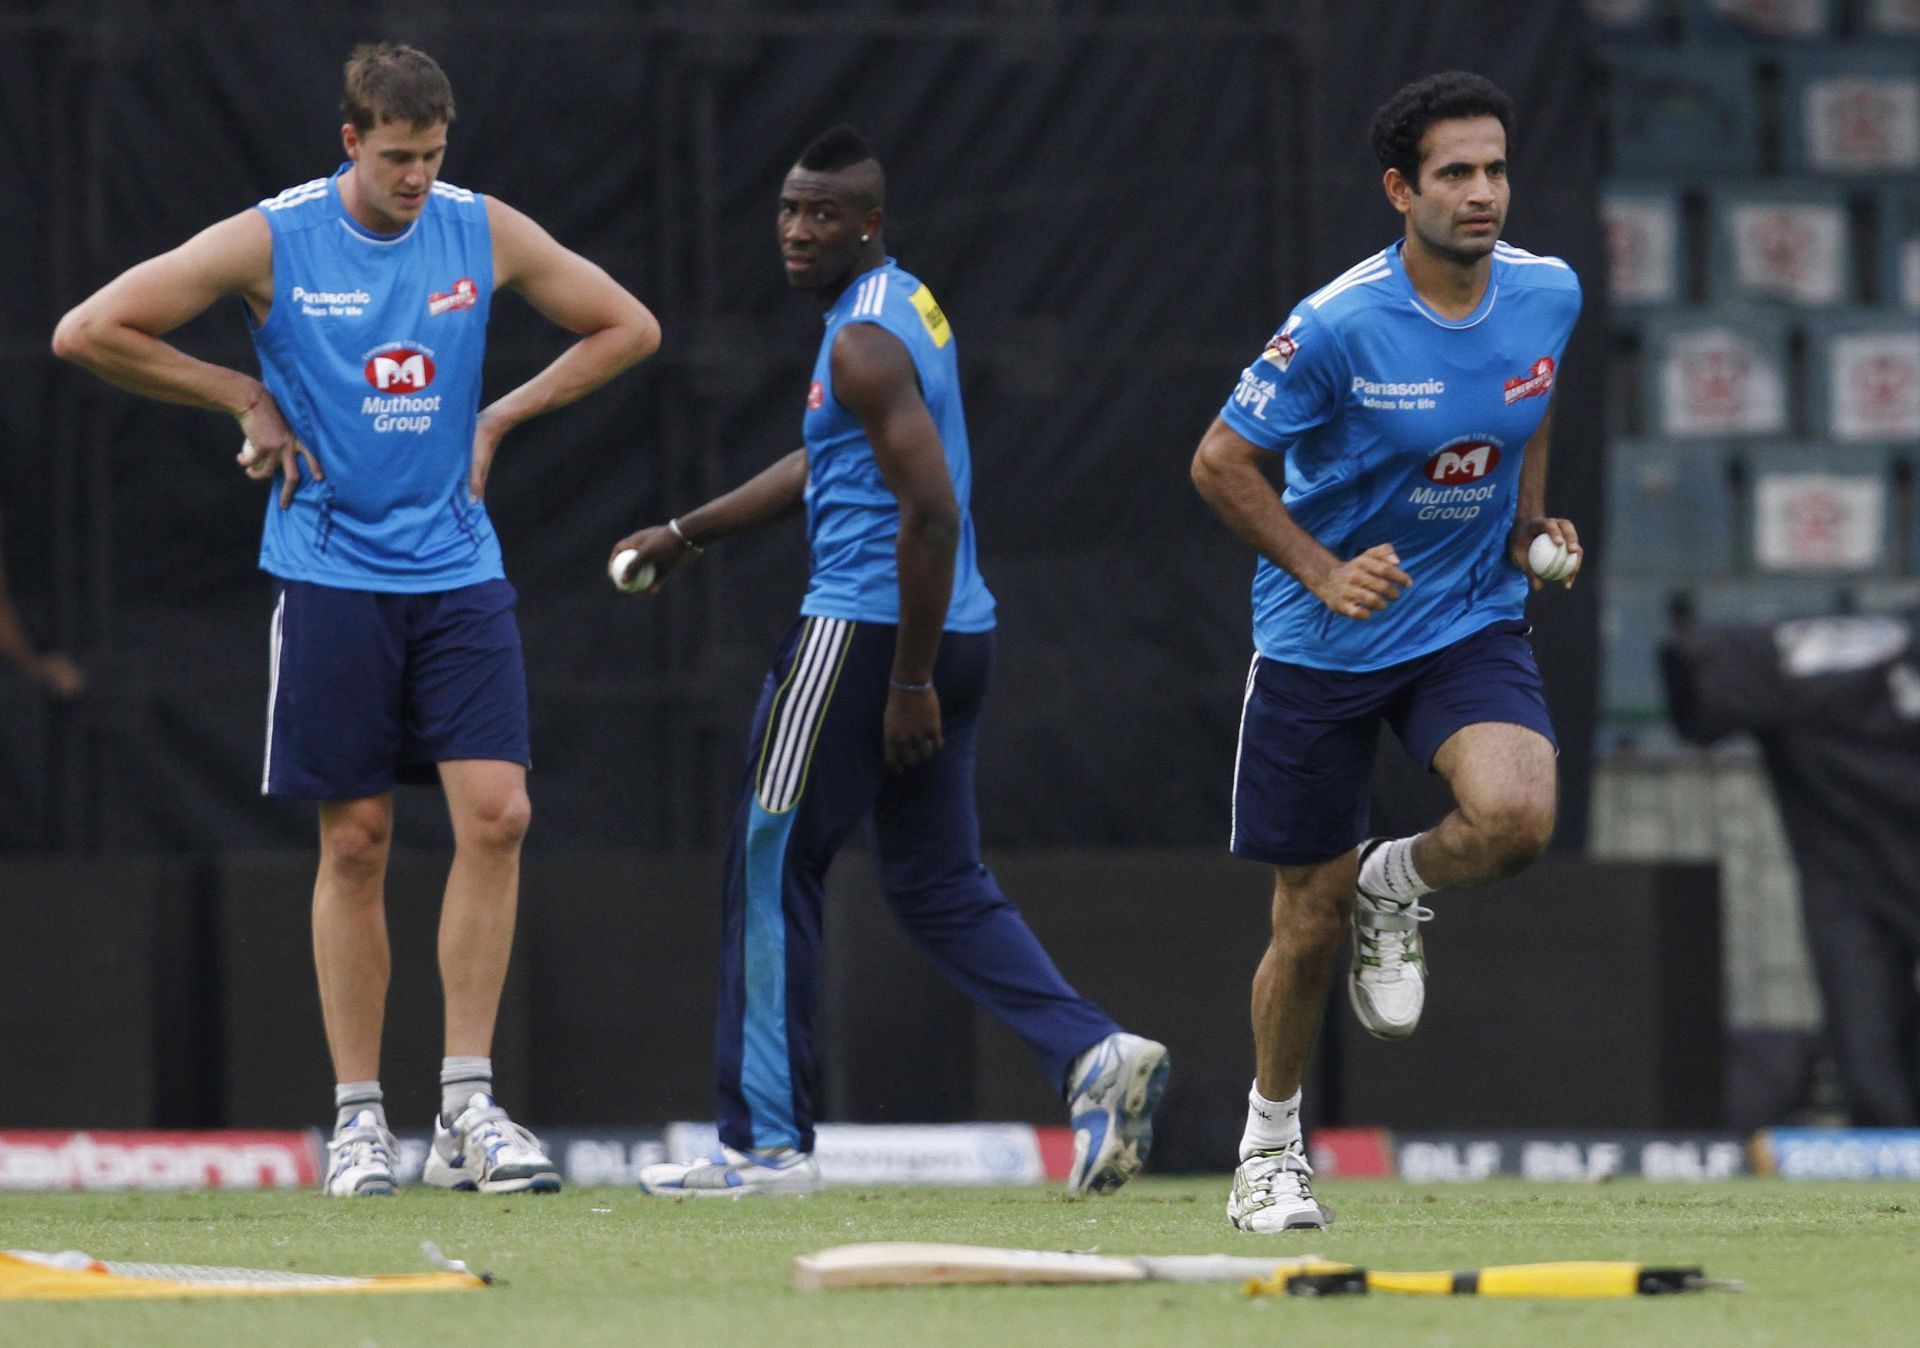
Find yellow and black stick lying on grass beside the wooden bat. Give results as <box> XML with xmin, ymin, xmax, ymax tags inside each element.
<box><xmin>1240</xmin><ymin>1260</ymin><xmax>1740</xmax><ymax>1298</ymax></box>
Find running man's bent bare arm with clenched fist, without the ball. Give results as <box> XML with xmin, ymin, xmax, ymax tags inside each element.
<box><xmin>1192</xmin><ymin>419</ymin><xmax>1413</xmax><ymax>618</ymax></box>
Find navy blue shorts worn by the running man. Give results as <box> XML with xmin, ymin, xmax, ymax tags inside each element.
<box><xmin>1231</xmin><ymin>622</ymin><xmax>1557</xmax><ymax>866</ymax></box>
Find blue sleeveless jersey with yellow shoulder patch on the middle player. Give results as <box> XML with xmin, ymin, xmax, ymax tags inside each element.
<box><xmin>801</xmin><ymin>257</ymin><xmax>993</xmax><ymax>632</ymax></box>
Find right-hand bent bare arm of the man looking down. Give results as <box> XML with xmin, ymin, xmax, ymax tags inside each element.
<box><xmin>468</xmin><ymin>198</ymin><xmax>660</xmax><ymax>501</ymax></box>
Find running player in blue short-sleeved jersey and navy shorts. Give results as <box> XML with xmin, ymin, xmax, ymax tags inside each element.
<box><xmin>1192</xmin><ymin>73</ymin><xmax>1580</xmax><ymax>1231</ymax></box>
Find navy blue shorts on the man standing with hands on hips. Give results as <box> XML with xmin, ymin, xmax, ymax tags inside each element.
<box><xmin>259</xmin><ymin>580</ymin><xmax>532</xmax><ymax>801</ymax></box>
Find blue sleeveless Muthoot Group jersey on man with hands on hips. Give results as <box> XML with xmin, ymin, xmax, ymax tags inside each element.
<box><xmin>253</xmin><ymin>165</ymin><xmax>505</xmax><ymax>593</ymax></box>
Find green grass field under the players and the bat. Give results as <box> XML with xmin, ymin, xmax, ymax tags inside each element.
<box><xmin>0</xmin><ymin>1177</ymin><xmax>1920</xmax><ymax>1348</ymax></box>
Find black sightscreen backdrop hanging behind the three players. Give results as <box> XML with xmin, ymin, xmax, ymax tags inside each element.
<box><xmin>0</xmin><ymin>0</ymin><xmax>1603</xmax><ymax>853</ymax></box>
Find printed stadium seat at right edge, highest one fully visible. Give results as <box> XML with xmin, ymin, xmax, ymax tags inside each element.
<box><xmin>1782</xmin><ymin>44</ymin><xmax>1920</xmax><ymax>175</ymax></box>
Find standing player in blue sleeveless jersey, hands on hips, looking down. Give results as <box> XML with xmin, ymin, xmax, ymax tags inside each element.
<box><xmin>54</xmin><ymin>44</ymin><xmax>659</xmax><ymax>1196</ymax></box>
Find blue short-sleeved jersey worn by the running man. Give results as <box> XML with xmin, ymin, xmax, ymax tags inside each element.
<box><xmin>1221</xmin><ymin>242</ymin><xmax>1580</xmax><ymax>672</ymax></box>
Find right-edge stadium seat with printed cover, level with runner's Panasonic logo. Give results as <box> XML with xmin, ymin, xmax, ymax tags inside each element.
<box><xmin>1807</xmin><ymin>309</ymin><xmax>1920</xmax><ymax>444</ymax></box>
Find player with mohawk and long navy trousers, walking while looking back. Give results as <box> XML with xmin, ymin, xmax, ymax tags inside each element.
<box><xmin>612</xmin><ymin>127</ymin><xmax>1167</xmax><ymax>1196</ymax></box>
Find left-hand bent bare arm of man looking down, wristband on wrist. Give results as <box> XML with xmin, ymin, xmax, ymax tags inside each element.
<box><xmin>54</xmin><ymin>211</ymin><xmax>324</xmax><ymax>507</ymax></box>
